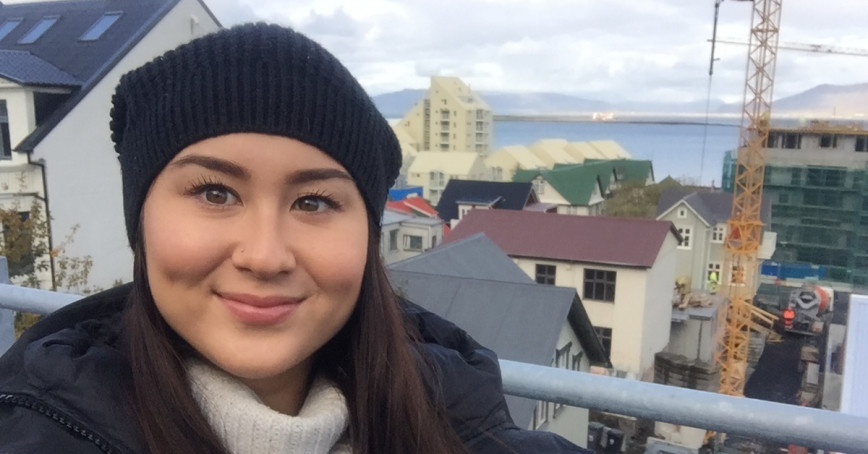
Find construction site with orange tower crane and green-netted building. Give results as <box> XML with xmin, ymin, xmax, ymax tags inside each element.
<box><xmin>635</xmin><ymin>0</ymin><xmax>868</xmax><ymax>454</ymax></box>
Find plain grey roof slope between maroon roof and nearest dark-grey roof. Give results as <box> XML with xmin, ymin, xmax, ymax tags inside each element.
<box><xmin>389</xmin><ymin>233</ymin><xmax>535</xmax><ymax>284</ymax></box>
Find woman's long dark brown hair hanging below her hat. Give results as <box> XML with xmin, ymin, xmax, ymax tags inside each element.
<box><xmin>125</xmin><ymin>226</ymin><xmax>467</xmax><ymax>454</ymax></box>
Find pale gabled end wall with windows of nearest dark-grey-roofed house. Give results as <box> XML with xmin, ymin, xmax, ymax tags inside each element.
<box><xmin>529</xmin><ymin>322</ymin><xmax>591</xmax><ymax>447</ymax></box>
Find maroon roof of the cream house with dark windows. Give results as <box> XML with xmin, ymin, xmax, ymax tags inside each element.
<box><xmin>443</xmin><ymin>210</ymin><xmax>678</xmax><ymax>268</ymax></box>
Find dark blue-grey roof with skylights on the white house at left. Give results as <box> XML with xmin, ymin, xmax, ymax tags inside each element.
<box><xmin>0</xmin><ymin>0</ymin><xmax>219</xmax><ymax>151</ymax></box>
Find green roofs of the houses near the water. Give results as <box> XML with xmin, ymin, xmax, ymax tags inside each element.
<box><xmin>512</xmin><ymin>159</ymin><xmax>653</xmax><ymax>206</ymax></box>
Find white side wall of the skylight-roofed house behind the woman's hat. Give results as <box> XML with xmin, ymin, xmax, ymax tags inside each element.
<box><xmin>33</xmin><ymin>0</ymin><xmax>218</xmax><ymax>288</ymax></box>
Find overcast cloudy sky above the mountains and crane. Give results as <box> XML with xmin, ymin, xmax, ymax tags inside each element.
<box><xmin>195</xmin><ymin>0</ymin><xmax>868</xmax><ymax>102</ymax></box>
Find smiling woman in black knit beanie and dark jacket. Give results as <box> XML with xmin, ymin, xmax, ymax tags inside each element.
<box><xmin>0</xmin><ymin>24</ymin><xmax>580</xmax><ymax>454</ymax></box>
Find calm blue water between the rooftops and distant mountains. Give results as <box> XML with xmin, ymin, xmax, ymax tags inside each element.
<box><xmin>494</xmin><ymin>121</ymin><xmax>739</xmax><ymax>187</ymax></box>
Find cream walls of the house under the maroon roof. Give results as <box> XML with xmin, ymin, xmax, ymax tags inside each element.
<box><xmin>513</xmin><ymin>255</ymin><xmax>675</xmax><ymax>378</ymax></box>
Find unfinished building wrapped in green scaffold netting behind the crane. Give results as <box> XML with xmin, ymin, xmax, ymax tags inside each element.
<box><xmin>721</xmin><ymin>121</ymin><xmax>868</xmax><ymax>286</ymax></box>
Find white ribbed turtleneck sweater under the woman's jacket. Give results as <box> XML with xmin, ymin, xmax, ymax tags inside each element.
<box><xmin>187</xmin><ymin>360</ymin><xmax>352</xmax><ymax>454</ymax></box>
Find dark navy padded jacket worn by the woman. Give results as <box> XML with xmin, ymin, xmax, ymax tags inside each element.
<box><xmin>0</xmin><ymin>285</ymin><xmax>588</xmax><ymax>454</ymax></box>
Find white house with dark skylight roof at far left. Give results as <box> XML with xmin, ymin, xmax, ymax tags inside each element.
<box><xmin>0</xmin><ymin>0</ymin><xmax>220</xmax><ymax>288</ymax></box>
